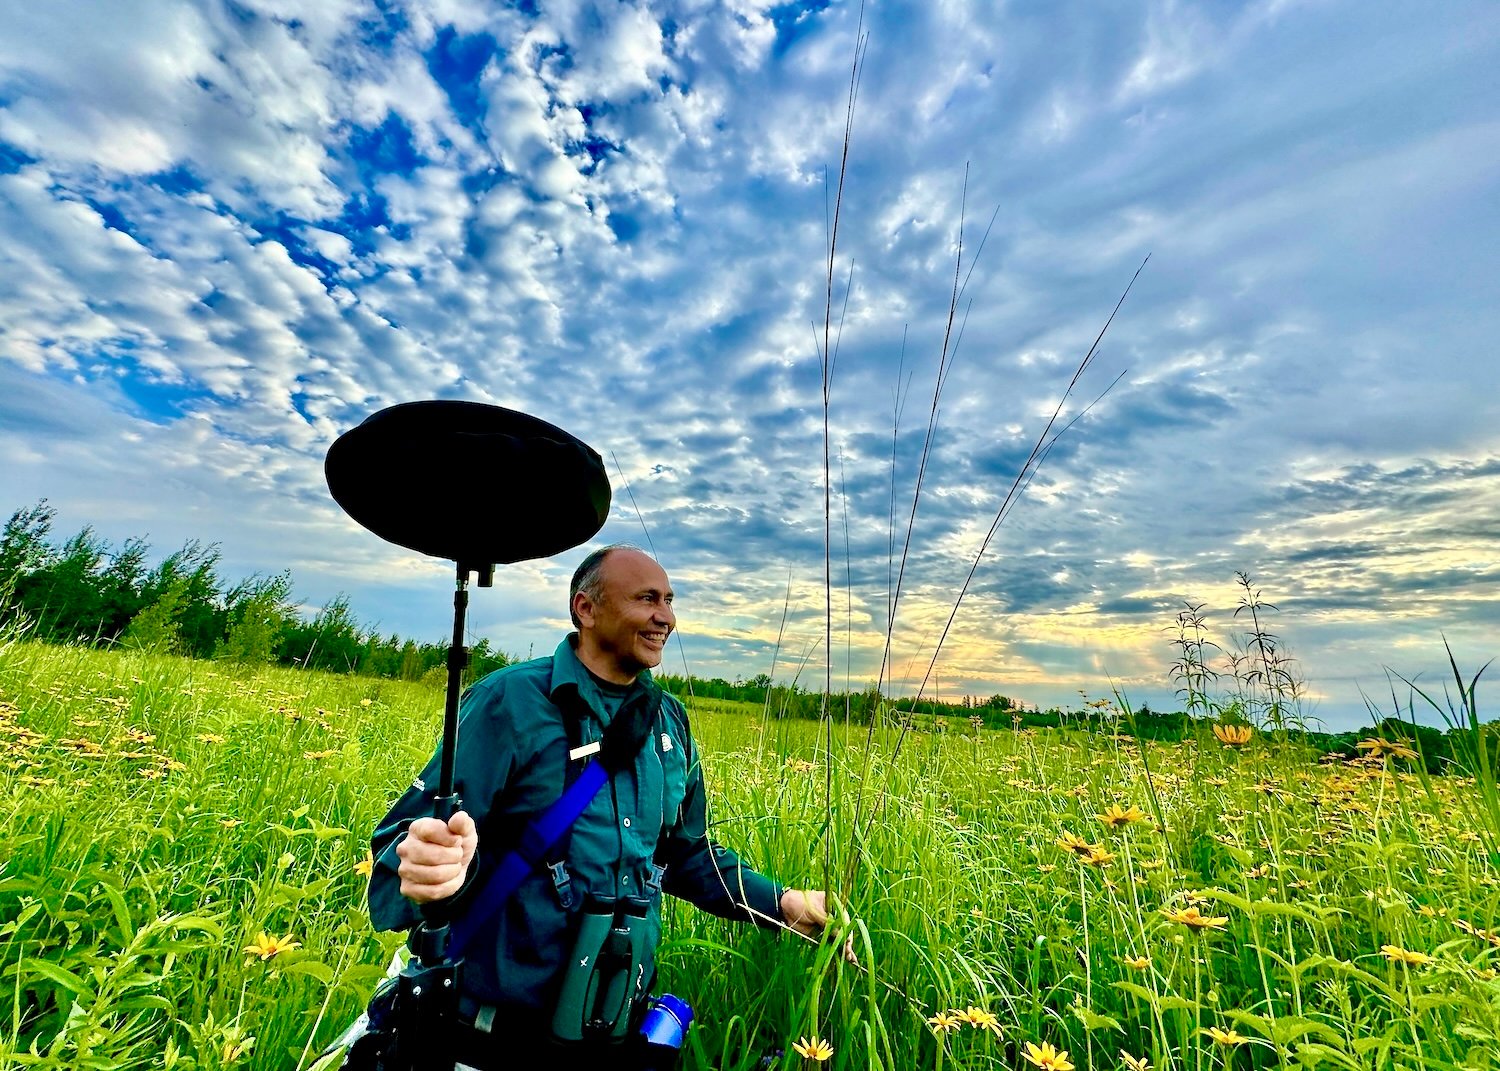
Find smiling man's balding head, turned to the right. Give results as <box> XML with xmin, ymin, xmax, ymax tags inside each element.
<box><xmin>573</xmin><ymin>549</ymin><xmax>677</xmax><ymax>684</ymax></box>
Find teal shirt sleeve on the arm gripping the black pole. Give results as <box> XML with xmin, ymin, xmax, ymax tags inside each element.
<box><xmin>369</xmin><ymin>681</ymin><xmax>516</xmax><ymax>930</ymax></box>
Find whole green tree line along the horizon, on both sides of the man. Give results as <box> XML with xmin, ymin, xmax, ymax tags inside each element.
<box><xmin>0</xmin><ymin>498</ymin><xmax>1482</xmax><ymax>773</ymax></box>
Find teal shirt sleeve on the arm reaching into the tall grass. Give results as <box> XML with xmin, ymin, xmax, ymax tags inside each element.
<box><xmin>657</xmin><ymin>734</ymin><xmax>785</xmax><ymax>929</ymax></box>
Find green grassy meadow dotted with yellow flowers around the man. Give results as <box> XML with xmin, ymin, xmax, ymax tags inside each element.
<box><xmin>0</xmin><ymin>639</ymin><xmax>1500</xmax><ymax>1071</ymax></box>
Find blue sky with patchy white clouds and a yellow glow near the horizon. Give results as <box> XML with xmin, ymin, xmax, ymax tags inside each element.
<box><xmin>0</xmin><ymin>0</ymin><xmax>1500</xmax><ymax>728</ymax></box>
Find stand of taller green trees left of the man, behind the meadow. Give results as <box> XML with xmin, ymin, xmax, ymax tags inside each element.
<box><xmin>0</xmin><ymin>498</ymin><xmax>510</xmax><ymax>681</ymax></box>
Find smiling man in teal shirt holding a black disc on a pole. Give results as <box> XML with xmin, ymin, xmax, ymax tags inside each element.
<box><xmin>369</xmin><ymin>546</ymin><xmax>828</xmax><ymax>1068</ymax></box>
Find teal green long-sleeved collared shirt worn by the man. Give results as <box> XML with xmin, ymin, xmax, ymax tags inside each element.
<box><xmin>369</xmin><ymin>636</ymin><xmax>783</xmax><ymax>1011</ymax></box>
